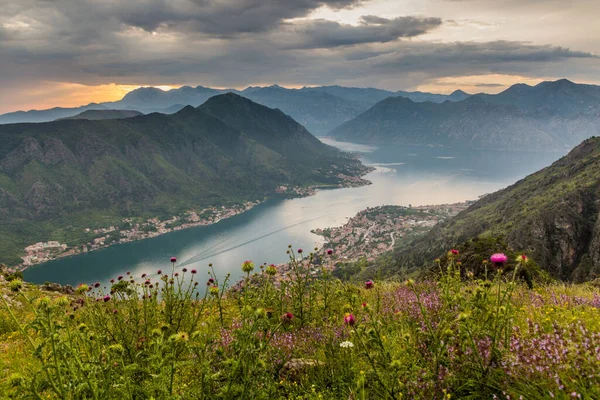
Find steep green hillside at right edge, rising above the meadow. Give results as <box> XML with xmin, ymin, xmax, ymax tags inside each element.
<box><xmin>384</xmin><ymin>137</ymin><xmax>600</xmax><ymax>281</ymax></box>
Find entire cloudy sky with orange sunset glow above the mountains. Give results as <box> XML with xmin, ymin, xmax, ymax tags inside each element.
<box><xmin>0</xmin><ymin>0</ymin><xmax>600</xmax><ymax>113</ymax></box>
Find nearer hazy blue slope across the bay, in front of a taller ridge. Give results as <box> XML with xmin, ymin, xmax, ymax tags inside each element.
<box><xmin>331</xmin><ymin>97</ymin><xmax>564</xmax><ymax>150</ymax></box>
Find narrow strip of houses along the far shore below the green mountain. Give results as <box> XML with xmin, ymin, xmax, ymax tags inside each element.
<box><xmin>16</xmin><ymin>171</ymin><xmax>374</xmax><ymax>272</ymax></box>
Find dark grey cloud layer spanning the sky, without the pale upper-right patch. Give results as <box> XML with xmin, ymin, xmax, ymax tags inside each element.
<box><xmin>0</xmin><ymin>0</ymin><xmax>600</xmax><ymax>101</ymax></box>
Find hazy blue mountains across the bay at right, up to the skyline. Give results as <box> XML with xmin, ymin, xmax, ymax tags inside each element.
<box><xmin>330</xmin><ymin>79</ymin><xmax>600</xmax><ymax>150</ymax></box>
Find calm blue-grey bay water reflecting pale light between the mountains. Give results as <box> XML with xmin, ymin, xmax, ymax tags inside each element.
<box><xmin>24</xmin><ymin>139</ymin><xmax>563</xmax><ymax>285</ymax></box>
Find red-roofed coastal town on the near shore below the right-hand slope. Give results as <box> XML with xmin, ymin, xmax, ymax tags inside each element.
<box><xmin>312</xmin><ymin>201</ymin><xmax>473</xmax><ymax>262</ymax></box>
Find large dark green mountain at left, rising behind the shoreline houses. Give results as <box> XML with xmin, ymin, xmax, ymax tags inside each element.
<box><xmin>0</xmin><ymin>93</ymin><xmax>365</xmax><ymax>263</ymax></box>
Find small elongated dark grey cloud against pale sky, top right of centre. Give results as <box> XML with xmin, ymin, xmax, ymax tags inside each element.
<box><xmin>290</xmin><ymin>15</ymin><xmax>442</xmax><ymax>48</ymax></box>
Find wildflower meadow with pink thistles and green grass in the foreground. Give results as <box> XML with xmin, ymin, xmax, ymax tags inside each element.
<box><xmin>0</xmin><ymin>248</ymin><xmax>600</xmax><ymax>399</ymax></box>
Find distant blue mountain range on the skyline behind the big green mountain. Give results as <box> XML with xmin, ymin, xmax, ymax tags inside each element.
<box><xmin>0</xmin><ymin>85</ymin><xmax>469</xmax><ymax>135</ymax></box>
